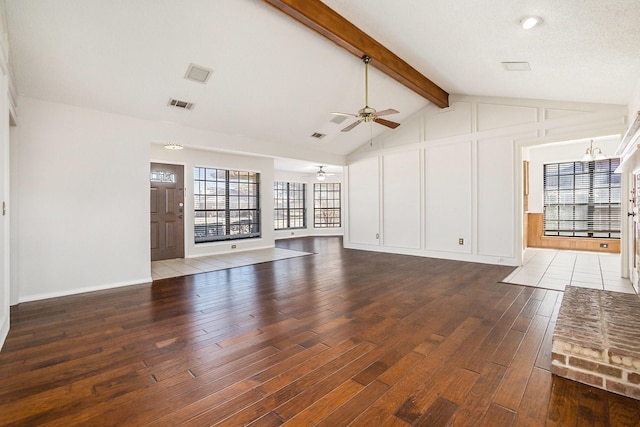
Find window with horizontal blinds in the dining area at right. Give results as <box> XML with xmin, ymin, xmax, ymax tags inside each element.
<box><xmin>543</xmin><ymin>159</ymin><xmax>622</xmax><ymax>239</ymax></box>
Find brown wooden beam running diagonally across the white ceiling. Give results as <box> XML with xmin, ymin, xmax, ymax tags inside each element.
<box><xmin>263</xmin><ymin>0</ymin><xmax>449</xmax><ymax>108</ymax></box>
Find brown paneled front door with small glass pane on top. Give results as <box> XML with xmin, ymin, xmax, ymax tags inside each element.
<box><xmin>150</xmin><ymin>163</ymin><xmax>184</xmax><ymax>261</ymax></box>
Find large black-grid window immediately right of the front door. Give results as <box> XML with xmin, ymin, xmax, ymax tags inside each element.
<box><xmin>193</xmin><ymin>167</ymin><xmax>260</xmax><ymax>243</ymax></box>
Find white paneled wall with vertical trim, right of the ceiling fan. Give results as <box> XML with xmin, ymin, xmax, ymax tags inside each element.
<box><xmin>345</xmin><ymin>96</ymin><xmax>627</xmax><ymax>265</ymax></box>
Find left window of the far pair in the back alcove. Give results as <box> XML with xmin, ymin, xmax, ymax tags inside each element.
<box><xmin>273</xmin><ymin>181</ymin><xmax>307</xmax><ymax>230</ymax></box>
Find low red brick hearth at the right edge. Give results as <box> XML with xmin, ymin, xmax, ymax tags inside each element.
<box><xmin>551</xmin><ymin>286</ymin><xmax>640</xmax><ymax>400</ymax></box>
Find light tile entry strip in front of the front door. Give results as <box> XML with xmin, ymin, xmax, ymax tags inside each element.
<box><xmin>151</xmin><ymin>248</ymin><xmax>311</xmax><ymax>280</ymax></box>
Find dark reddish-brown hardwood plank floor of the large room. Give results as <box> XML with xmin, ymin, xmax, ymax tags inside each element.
<box><xmin>0</xmin><ymin>237</ymin><xmax>640</xmax><ymax>427</ymax></box>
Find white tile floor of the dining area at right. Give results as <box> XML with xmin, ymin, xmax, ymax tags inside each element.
<box><xmin>503</xmin><ymin>248</ymin><xmax>635</xmax><ymax>293</ymax></box>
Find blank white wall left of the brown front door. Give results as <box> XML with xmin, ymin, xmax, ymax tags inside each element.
<box><xmin>12</xmin><ymin>98</ymin><xmax>152</xmax><ymax>302</ymax></box>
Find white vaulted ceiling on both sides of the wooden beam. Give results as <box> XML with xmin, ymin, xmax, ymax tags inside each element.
<box><xmin>6</xmin><ymin>0</ymin><xmax>640</xmax><ymax>172</ymax></box>
